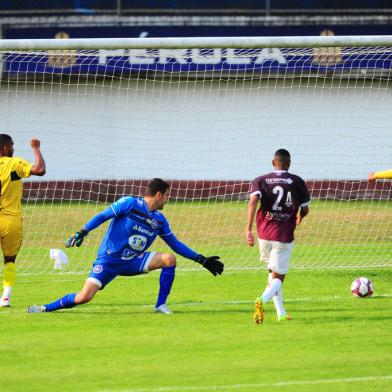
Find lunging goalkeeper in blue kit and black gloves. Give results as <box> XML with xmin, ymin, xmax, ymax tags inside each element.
<box><xmin>27</xmin><ymin>178</ymin><xmax>224</xmax><ymax>314</ymax></box>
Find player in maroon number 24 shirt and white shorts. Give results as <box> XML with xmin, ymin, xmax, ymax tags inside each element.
<box><xmin>246</xmin><ymin>149</ymin><xmax>310</xmax><ymax>324</ymax></box>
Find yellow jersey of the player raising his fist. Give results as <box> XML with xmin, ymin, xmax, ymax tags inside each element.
<box><xmin>0</xmin><ymin>157</ymin><xmax>33</xmax><ymax>215</ymax></box>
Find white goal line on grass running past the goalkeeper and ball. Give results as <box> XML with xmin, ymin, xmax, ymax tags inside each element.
<box><xmin>0</xmin><ymin>294</ymin><xmax>392</xmax><ymax>315</ymax></box>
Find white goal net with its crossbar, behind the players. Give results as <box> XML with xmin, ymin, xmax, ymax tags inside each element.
<box><xmin>0</xmin><ymin>37</ymin><xmax>392</xmax><ymax>274</ymax></box>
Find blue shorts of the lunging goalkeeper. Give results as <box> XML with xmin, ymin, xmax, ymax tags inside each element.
<box><xmin>87</xmin><ymin>252</ymin><xmax>156</xmax><ymax>290</ymax></box>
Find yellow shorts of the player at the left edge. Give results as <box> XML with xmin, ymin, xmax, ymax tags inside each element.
<box><xmin>0</xmin><ymin>214</ymin><xmax>23</xmax><ymax>256</ymax></box>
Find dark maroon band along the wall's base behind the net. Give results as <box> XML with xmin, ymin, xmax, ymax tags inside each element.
<box><xmin>23</xmin><ymin>180</ymin><xmax>392</xmax><ymax>203</ymax></box>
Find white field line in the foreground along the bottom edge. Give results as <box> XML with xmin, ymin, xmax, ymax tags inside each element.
<box><xmin>104</xmin><ymin>374</ymin><xmax>392</xmax><ymax>392</ymax></box>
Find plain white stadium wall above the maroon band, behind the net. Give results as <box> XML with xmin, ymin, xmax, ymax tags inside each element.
<box><xmin>0</xmin><ymin>78</ymin><xmax>392</xmax><ymax>181</ymax></box>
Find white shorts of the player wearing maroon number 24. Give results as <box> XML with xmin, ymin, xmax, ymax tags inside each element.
<box><xmin>259</xmin><ymin>238</ymin><xmax>294</xmax><ymax>275</ymax></box>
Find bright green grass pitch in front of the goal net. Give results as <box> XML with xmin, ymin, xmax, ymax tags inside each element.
<box><xmin>0</xmin><ymin>201</ymin><xmax>392</xmax><ymax>392</ymax></box>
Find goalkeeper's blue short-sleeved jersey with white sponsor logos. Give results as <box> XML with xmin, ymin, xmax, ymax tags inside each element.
<box><xmin>98</xmin><ymin>196</ymin><xmax>171</xmax><ymax>260</ymax></box>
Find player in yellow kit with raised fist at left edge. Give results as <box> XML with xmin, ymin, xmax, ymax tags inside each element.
<box><xmin>0</xmin><ymin>134</ymin><xmax>46</xmax><ymax>307</ymax></box>
